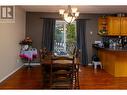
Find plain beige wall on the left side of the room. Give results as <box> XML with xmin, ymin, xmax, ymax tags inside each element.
<box><xmin>0</xmin><ymin>7</ymin><xmax>26</xmax><ymax>81</ymax></box>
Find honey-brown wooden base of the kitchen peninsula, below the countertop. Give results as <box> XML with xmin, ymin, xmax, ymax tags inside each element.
<box><xmin>98</xmin><ymin>49</ymin><xmax>127</xmax><ymax>77</ymax></box>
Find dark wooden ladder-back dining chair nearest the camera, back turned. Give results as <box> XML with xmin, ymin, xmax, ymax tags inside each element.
<box><xmin>50</xmin><ymin>57</ymin><xmax>74</xmax><ymax>89</ymax></box>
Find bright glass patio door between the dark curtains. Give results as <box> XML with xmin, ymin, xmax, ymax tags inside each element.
<box><xmin>54</xmin><ymin>20</ymin><xmax>76</xmax><ymax>55</ymax></box>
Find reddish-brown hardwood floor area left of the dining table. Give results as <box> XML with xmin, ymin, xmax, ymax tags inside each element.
<box><xmin>0</xmin><ymin>66</ymin><xmax>42</xmax><ymax>89</ymax></box>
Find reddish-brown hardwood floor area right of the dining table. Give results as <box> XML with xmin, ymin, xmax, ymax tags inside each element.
<box><xmin>80</xmin><ymin>67</ymin><xmax>127</xmax><ymax>89</ymax></box>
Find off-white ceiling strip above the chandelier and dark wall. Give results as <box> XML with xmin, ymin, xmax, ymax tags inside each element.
<box><xmin>21</xmin><ymin>5</ymin><xmax>127</xmax><ymax>13</ymax></box>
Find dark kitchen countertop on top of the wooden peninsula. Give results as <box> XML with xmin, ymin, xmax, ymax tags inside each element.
<box><xmin>93</xmin><ymin>44</ymin><xmax>127</xmax><ymax>51</ymax></box>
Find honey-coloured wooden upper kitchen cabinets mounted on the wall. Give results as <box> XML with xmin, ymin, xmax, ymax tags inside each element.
<box><xmin>98</xmin><ymin>17</ymin><xmax>127</xmax><ymax>36</ymax></box>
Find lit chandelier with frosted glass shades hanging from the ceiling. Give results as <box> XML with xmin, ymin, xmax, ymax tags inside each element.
<box><xmin>59</xmin><ymin>5</ymin><xmax>79</xmax><ymax>23</ymax></box>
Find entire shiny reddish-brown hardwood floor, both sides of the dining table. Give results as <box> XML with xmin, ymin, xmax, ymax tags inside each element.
<box><xmin>0</xmin><ymin>66</ymin><xmax>127</xmax><ymax>89</ymax></box>
